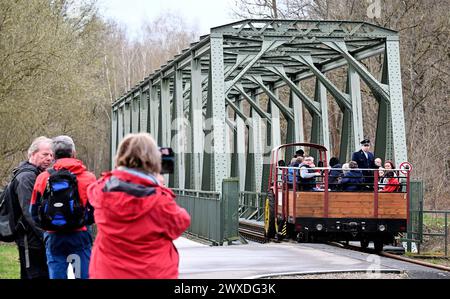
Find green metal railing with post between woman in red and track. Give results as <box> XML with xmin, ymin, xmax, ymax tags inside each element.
<box><xmin>172</xmin><ymin>179</ymin><xmax>239</xmax><ymax>245</ymax></box>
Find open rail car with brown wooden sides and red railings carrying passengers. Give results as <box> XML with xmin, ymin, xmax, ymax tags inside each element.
<box><xmin>264</xmin><ymin>143</ymin><xmax>411</xmax><ymax>251</ymax></box>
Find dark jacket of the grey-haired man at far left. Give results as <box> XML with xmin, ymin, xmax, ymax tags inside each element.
<box><xmin>11</xmin><ymin>162</ymin><xmax>45</xmax><ymax>249</ymax></box>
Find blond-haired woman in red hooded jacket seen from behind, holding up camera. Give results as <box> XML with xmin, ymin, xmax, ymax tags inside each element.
<box><xmin>88</xmin><ymin>133</ymin><xmax>190</xmax><ymax>279</ymax></box>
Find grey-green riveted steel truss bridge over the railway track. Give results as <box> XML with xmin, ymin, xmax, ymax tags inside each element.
<box><xmin>111</xmin><ymin>20</ymin><xmax>407</xmax><ymax>195</ymax></box>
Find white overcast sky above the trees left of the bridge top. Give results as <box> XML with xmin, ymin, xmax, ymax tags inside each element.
<box><xmin>99</xmin><ymin>0</ymin><xmax>241</xmax><ymax>37</ymax></box>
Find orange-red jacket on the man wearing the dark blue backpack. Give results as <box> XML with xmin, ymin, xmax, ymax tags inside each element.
<box><xmin>31</xmin><ymin>158</ymin><xmax>96</xmax><ymax>231</ymax></box>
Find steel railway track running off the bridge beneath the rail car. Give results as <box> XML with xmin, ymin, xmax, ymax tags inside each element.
<box><xmin>239</xmin><ymin>220</ymin><xmax>450</xmax><ymax>272</ymax></box>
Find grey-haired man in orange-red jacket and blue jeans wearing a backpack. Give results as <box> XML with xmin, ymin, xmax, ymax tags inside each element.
<box><xmin>31</xmin><ymin>136</ymin><xmax>96</xmax><ymax>279</ymax></box>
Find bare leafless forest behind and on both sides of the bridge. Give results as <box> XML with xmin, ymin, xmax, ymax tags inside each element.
<box><xmin>0</xmin><ymin>0</ymin><xmax>450</xmax><ymax>209</ymax></box>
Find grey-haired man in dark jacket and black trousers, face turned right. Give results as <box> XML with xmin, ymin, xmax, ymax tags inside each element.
<box><xmin>10</xmin><ymin>136</ymin><xmax>53</xmax><ymax>279</ymax></box>
